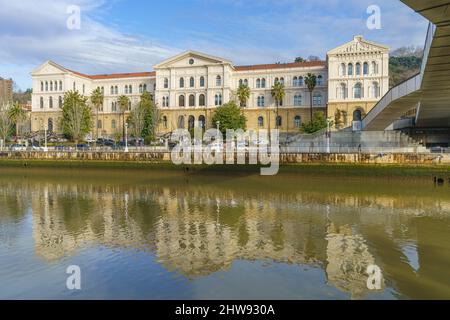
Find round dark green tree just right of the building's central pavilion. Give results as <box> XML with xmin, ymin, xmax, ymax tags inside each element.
<box><xmin>212</xmin><ymin>101</ymin><xmax>247</xmax><ymax>134</ymax></box>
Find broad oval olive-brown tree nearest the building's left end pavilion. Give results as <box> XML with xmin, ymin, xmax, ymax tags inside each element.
<box><xmin>60</xmin><ymin>91</ymin><xmax>92</xmax><ymax>143</ymax></box>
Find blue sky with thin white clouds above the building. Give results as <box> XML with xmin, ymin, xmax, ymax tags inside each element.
<box><xmin>0</xmin><ymin>0</ymin><xmax>427</xmax><ymax>89</ymax></box>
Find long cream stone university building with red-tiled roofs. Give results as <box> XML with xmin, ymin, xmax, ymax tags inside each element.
<box><xmin>31</xmin><ymin>36</ymin><xmax>389</xmax><ymax>137</ymax></box>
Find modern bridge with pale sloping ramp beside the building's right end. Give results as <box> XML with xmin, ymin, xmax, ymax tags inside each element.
<box><xmin>362</xmin><ymin>0</ymin><xmax>450</xmax><ymax>131</ymax></box>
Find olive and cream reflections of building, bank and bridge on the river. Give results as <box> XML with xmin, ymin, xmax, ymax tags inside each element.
<box><xmin>0</xmin><ymin>173</ymin><xmax>450</xmax><ymax>298</ymax></box>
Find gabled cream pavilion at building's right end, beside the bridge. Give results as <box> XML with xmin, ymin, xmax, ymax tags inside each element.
<box><xmin>327</xmin><ymin>36</ymin><xmax>389</xmax><ymax>129</ymax></box>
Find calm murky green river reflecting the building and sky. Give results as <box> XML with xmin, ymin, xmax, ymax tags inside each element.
<box><xmin>0</xmin><ymin>169</ymin><xmax>450</xmax><ymax>299</ymax></box>
